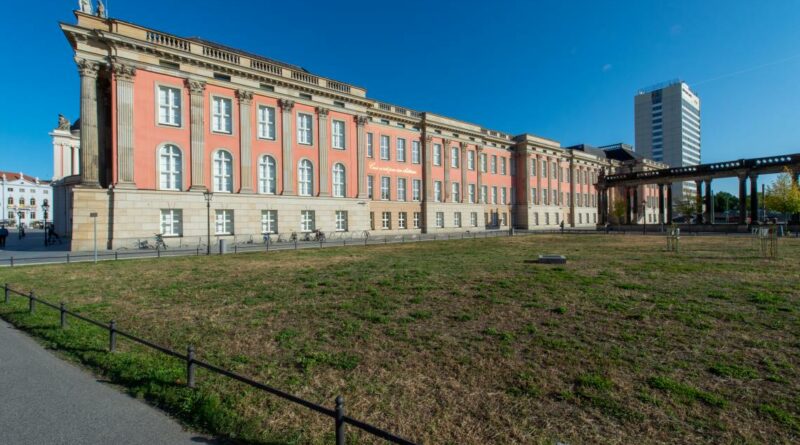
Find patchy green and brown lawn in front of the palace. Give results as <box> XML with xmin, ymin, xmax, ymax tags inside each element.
<box><xmin>0</xmin><ymin>235</ymin><xmax>800</xmax><ymax>444</ymax></box>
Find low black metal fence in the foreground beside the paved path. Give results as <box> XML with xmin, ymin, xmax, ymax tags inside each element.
<box><xmin>4</xmin><ymin>283</ymin><xmax>414</xmax><ymax>445</ymax></box>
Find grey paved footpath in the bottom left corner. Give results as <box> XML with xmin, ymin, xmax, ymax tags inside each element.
<box><xmin>0</xmin><ymin>320</ymin><xmax>221</xmax><ymax>445</ymax></box>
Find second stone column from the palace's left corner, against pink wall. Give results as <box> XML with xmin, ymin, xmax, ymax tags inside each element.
<box><xmin>112</xmin><ymin>61</ymin><xmax>136</xmax><ymax>188</ymax></box>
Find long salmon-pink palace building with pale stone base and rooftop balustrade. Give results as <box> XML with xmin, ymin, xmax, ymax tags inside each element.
<box><xmin>54</xmin><ymin>11</ymin><xmax>664</xmax><ymax>250</ymax></box>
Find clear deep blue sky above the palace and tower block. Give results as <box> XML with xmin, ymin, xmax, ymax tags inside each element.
<box><xmin>0</xmin><ymin>0</ymin><xmax>800</xmax><ymax>193</ymax></box>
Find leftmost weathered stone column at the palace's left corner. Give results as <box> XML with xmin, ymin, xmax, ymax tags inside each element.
<box><xmin>75</xmin><ymin>59</ymin><xmax>101</xmax><ymax>187</ymax></box>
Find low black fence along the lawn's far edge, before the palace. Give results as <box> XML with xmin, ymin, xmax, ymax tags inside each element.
<box><xmin>0</xmin><ymin>230</ymin><xmax>511</xmax><ymax>267</ymax></box>
